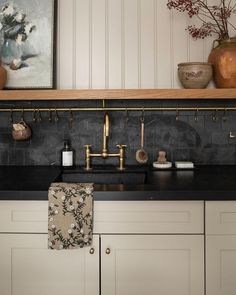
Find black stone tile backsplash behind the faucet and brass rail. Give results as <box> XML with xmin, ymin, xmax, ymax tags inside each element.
<box><xmin>0</xmin><ymin>100</ymin><xmax>236</xmax><ymax>165</ymax></box>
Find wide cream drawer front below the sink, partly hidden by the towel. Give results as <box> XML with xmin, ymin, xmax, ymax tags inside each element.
<box><xmin>0</xmin><ymin>201</ymin><xmax>204</xmax><ymax>233</ymax></box>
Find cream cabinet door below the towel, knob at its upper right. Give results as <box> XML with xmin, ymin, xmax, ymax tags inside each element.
<box><xmin>0</xmin><ymin>234</ymin><xmax>99</xmax><ymax>295</ymax></box>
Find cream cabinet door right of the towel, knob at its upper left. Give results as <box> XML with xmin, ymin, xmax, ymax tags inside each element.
<box><xmin>101</xmin><ymin>235</ymin><xmax>204</xmax><ymax>295</ymax></box>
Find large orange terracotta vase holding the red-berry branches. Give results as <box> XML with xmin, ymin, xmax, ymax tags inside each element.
<box><xmin>208</xmin><ymin>38</ymin><xmax>236</xmax><ymax>88</ymax></box>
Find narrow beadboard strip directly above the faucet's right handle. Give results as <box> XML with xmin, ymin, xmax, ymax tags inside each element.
<box><xmin>121</xmin><ymin>0</ymin><xmax>125</xmax><ymax>88</ymax></box>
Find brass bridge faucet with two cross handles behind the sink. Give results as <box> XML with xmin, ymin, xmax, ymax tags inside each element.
<box><xmin>85</xmin><ymin>113</ymin><xmax>126</xmax><ymax>171</ymax></box>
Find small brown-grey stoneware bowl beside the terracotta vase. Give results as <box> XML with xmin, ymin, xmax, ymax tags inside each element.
<box><xmin>178</xmin><ymin>62</ymin><xmax>213</xmax><ymax>89</ymax></box>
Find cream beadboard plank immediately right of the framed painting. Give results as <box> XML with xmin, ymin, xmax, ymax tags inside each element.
<box><xmin>57</xmin><ymin>0</ymin><xmax>74</xmax><ymax>89</ymax></box>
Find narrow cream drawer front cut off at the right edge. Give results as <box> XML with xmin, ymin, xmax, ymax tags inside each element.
<box><xmin>206</xmin><ymin>201</ymin><xmax>236</xmax><ymax>235</ymax></box>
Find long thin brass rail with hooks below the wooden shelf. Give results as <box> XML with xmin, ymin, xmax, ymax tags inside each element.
<box><xmin>0</xmin><ymin>107</ymin><xmax>236</xmax><ymax>112</ymax></box>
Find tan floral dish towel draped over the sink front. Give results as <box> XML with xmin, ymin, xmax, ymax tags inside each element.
<box><xmin>48</xmin><ymin>183</ymin><xmax>93</xmax><ymax>250</ymax></box>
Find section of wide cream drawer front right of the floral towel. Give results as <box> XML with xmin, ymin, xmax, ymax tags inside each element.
<box><xmin>94</xmin><ymin>201</ymin><xmax>204</xmax><ymax>234</ymax></box>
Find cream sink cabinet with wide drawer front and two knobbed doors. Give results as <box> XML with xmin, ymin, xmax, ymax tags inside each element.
<box><xmin>0</xmin><ymin>201</ymin><xmax>204</xmax><ymax>295</ymax></box>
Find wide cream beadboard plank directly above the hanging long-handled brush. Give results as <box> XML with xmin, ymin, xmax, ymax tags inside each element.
<box><xmin>140</xmin><ymin>0</ymin><xmax>155</xmax><ymax>88</ymax></box>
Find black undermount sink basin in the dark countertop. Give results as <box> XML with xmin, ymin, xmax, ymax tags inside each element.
<box><xmin>61</xmin><ymin>170</ymin><xmax>147</xmax><ymax>184</ymax></box>
